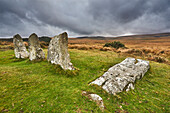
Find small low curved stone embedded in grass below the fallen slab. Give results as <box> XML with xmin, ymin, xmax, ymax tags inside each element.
<box><xmin>82</xmin><ymin>91</ymin><xmax>105</xmax><ymax>111</ymax></box>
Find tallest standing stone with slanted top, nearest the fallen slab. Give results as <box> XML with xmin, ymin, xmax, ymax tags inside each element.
<box><xmin>47</xmin><ymin>32</ymin><xmax>74</xmax><ymax>70</ymax></box>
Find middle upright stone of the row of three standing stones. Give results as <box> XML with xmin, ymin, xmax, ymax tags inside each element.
<box><xmin>28</xmin><ymin>33</ymin><xmax>45</xmax><ymax>61</ymax></box>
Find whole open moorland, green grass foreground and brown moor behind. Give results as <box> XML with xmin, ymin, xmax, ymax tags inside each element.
<box><xmin>0</xmin><ymin>34</ymin><xmax>170</xmax><ymax>113</ymax></box>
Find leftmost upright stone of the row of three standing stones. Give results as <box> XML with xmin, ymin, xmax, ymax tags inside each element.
<box><xmin>13</xmin><ymin>34</ymin><xmax>29</xmax><ymax>58</ymax></box>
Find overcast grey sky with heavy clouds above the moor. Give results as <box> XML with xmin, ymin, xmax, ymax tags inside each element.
<box><xmin>0</xmin><ymin>0</ymin><xmax>170</xmax><ymax>37</ymax></box>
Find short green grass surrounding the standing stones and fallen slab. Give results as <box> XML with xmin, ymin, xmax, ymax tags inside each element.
<box><xmin>0</xmin><ymin>49</ymin><xmax>170</xmax><ymax>113</ymax></box>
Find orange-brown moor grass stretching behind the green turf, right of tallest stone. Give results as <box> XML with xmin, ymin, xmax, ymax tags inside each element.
<box><xmin>69</xmin><ymin>33</ymin><xmax>170</xmax><ymax>64</ymax></box>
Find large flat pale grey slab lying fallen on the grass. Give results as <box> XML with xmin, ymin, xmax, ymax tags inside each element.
<box><xmin>90</xmin><ymin>58</ymin><xmax>150</xmax><ymax>94</ymax></box>
